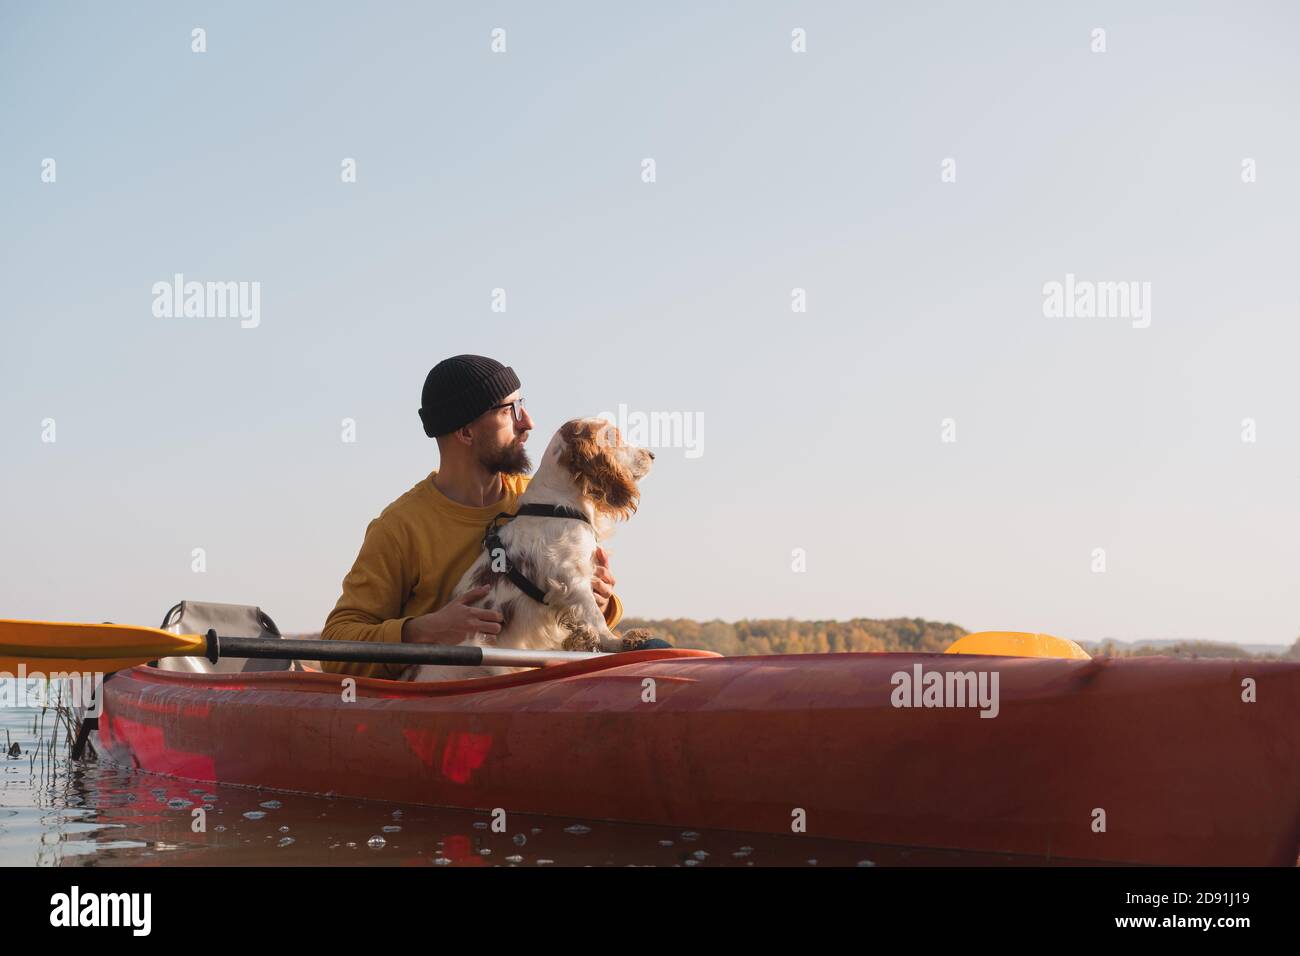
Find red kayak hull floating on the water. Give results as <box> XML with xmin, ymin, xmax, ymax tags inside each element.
<box><xmin>99</xmin><ymin>650</ymin><xmax>1300</xmax><ymax>866</ymax></box>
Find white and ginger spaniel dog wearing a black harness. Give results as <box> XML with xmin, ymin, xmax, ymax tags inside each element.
<box><xmin>403</xmin><ymin>419</ymin><xmax>654</xmax><ymax>680</ymax></box>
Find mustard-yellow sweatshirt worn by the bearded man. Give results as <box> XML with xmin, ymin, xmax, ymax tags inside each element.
<box><xmin>321</xmin><ymin>471</ymin><xmax>623</xmax><ymax>678</ymax></box>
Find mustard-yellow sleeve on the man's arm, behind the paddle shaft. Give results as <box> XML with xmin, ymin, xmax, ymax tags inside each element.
<box><xmin>321</xmin><ymin>519</ymin><xmax>411</xmax><ymax>679</ymax></box>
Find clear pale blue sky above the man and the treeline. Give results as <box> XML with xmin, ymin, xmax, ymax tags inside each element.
<box><xmin>0</xmin><ymin>1</ymin><xmax>1300</xmax><ymax>644</ymax></box>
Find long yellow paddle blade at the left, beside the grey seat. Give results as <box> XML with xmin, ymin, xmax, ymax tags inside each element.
<box><xmin>0</xmin><ymin>620</ymin><xmax>207</xmax><ymax>676</ymax></box>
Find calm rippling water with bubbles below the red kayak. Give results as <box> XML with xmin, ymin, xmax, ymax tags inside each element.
<box><xmin>0</xmin><ymin>686</ymin><xmax>1050</xmax><ymax>866</ymax></box>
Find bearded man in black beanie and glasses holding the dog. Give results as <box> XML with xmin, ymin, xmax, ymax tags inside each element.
<box><xmin>321</xmin><ymin>355</ymin><xmax>623</xmax><ymax>678</ymax></box>
